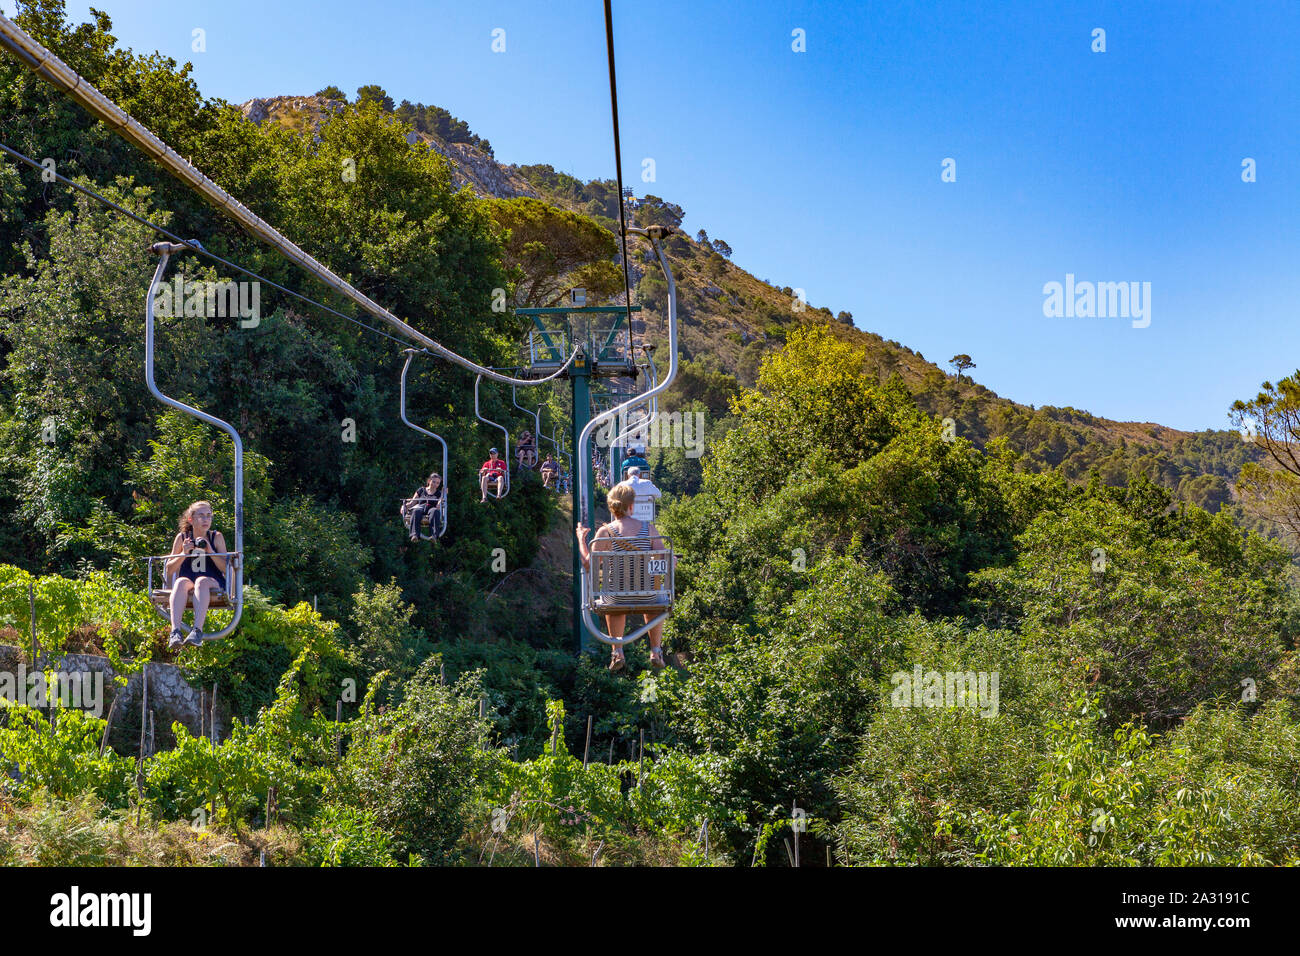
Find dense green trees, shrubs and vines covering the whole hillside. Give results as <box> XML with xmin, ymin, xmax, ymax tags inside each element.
<box><xmin>0</xmin><ymin>0</ymin><xmax>1300</xmax><ymax>866</ymax></box>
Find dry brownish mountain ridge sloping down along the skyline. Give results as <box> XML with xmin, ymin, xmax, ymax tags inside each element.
<box><xmin>239</xmin><ymin>95</ymin><xmax>1261</xmax><ymax>520</ymax></box>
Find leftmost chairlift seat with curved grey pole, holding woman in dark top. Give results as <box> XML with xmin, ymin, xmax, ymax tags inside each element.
<box><xmin>144</xmin><ymin>241</ymin><xmax>244</xmax><ymax>641</ymax></box>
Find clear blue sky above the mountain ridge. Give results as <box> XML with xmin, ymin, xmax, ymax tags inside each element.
<box><xmin>38</xmin><ymin>0</ymin><xmax>1300</xmax><ymax>429</ymax></box>
